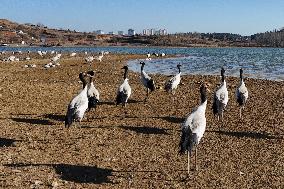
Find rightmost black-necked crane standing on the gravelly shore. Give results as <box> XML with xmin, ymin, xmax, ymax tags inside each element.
<box><xmin>236</xmin><ymin>68</ymin><xmax>248</xmax><ymax>119</ymax></box>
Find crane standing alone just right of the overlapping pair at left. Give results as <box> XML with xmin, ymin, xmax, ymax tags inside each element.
<box><xmin>116</xmin><ymin>66</ymin><xmax>131</xmax><ymax>107</ymax></box>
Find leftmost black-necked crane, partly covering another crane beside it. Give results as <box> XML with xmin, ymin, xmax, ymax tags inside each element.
<box><xmin>65</xmin><ymin>72</ymin><xmax>88</xmax><ymax>128</ymax></box>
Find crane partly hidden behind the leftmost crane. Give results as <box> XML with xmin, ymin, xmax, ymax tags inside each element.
<box><xmin>87</xmin><ymin>71</ymin><xmax>100</xmax><ymax>111</ymax></box>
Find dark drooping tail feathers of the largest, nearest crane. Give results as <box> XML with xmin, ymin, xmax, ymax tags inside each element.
<box><xmin>179</xmin><ymin>128</ymin><xmax>197</xmax><ymax>155</ymax></box>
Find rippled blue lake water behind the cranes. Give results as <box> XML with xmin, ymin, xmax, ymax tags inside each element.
<box><xmin>0</xmin><ymin>47</ymin><xmax>284</xmax><ymax>81</ymax></box>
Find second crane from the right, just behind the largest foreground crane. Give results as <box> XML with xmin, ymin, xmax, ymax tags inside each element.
<box><xmin>212</xmin><ymin>68</ymin><xmax>229</xmax><ymax>126</ymax></box>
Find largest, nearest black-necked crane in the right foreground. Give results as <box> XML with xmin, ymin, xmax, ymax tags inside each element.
<box><xmin>179</xmin><ymin>83</ymin><xmax>207</xmax><ymax>173</ymax></box>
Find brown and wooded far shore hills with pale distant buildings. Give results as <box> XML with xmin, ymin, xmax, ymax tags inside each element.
<box><xmin>0</xmin><ymin>19</ymin><xmax>284</xmax><ymax>47</ymax></box>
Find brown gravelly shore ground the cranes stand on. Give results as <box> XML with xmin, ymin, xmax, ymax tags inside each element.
<box><xmin>0</xmin><ymin>52</ymin><xmax>284</xmax><ymax>188</ymax></box>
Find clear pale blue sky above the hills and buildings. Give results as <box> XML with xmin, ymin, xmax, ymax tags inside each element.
<box><xmin>0</xmin><ymin>0</ymin><xmax>284</xmax><ymax>35</ymax></box>
